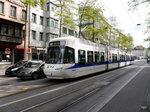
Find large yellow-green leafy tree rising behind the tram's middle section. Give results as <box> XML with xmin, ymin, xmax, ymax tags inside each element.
<box><xmin>79</xmin><ymin>0</ymin><xmax>109</xmax><ymax>42</ymax></box>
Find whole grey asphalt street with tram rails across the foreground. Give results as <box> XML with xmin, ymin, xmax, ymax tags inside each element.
<box><xmin>0</xmin><ymin>61</ymin><xmax>150</xmax><ymax>112</ymax></box>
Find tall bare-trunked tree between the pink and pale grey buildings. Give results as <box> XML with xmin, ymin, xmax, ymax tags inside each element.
<box><xmin>22</xmin><ymin>0</ymin><xmax>46</xmax><ymax>60</ymax></box>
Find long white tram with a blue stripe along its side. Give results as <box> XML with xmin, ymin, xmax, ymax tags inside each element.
<box><xmin>43</xmin><ymin>37</ymin><xmax>133</xmax><ymax>79</ymax></box>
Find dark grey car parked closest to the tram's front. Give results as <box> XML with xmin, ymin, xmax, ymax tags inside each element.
<box><xmin>17</xmin><ymin>61</ymin><xmax>46</xmax><ymax>79</ymax></box>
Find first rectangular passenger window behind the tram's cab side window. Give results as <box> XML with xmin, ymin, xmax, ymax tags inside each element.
<box><xmin>78</xmin><ymin>50</ymin><xmax>86</xmax><ymax>65</ymax></box>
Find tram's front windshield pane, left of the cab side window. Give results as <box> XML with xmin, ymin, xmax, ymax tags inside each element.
<box><xmin>46</xmin><ymin>47</ymin><xmax>64</xmax><ymax>64</ymax></box>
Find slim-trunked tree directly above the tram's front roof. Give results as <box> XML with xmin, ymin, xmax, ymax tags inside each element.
<box><xmin>56</xmin><ymin>0</ymin><xmax>75</xmax><ymax>37</ymax></box>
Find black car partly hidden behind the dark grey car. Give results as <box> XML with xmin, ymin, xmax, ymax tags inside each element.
<box><xmin>5</xmin><ymin>61</ymin><xmax>28</xmax><ymax>76</ymax></box>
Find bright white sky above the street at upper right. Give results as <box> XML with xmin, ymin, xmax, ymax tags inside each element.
<box><xmin>99</xmin><ymin>0</ymin><xmax>150</xmax><ymax>47</ymax></box>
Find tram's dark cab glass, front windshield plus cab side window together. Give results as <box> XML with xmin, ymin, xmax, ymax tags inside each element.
<box><xmin>46</xmin><ymin>46</ymin><xmax>75</xmax><ymax>64</ymax></box>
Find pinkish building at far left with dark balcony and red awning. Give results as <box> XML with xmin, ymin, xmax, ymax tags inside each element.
<box><xmin>0</xmin><ymin>0</ymin><xmax>26</xmax><ymax>64</ymax></box>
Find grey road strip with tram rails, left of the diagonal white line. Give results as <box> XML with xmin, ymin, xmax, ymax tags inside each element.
<box><xmin>0</xmin><ymin>61</ymin><xmax>149</xmax><ymax>112</ymax></box>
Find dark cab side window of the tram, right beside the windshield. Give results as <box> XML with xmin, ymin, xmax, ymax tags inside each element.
<box><xmin>63</xmin><ymin>47</ymin><xmax>75</xmax><ymax>64</ymax></box>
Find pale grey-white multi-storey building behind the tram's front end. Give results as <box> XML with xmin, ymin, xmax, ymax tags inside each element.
<box><xmin>29</xmin><ymin>0</ymin><xmax>77</xmax><ymax>60</ymax></box>
